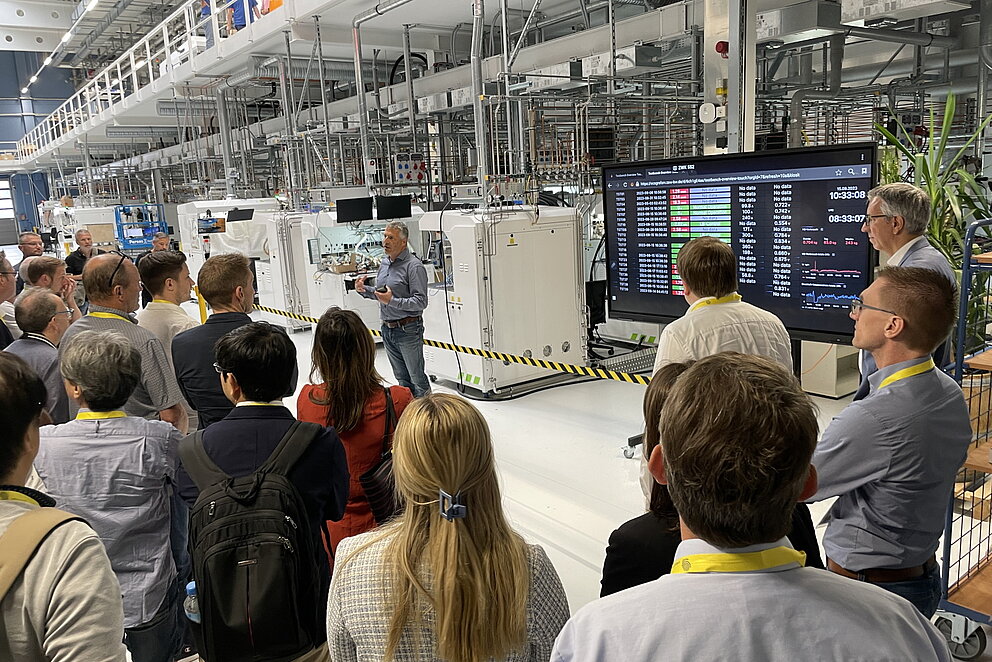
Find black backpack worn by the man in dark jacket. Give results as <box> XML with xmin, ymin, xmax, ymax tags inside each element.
<box><xmin>179</xmin><ymin>421</ymin><xmax>326</xmax><ymax>662</ymax></box>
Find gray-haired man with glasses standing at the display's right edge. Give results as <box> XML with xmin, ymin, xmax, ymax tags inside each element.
<box><xmin>854</xmin><ymin>182</ymin><xmax>958</xmax><ymax>400</ymax></box>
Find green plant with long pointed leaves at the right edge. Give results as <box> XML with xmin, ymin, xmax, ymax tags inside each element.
<box><xmin>875</xmin><ymin>95</ymin><xmax>992</xmax><ymax>354</ymax></box>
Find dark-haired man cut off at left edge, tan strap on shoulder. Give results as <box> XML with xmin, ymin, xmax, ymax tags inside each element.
<box><xmin>0</xmin><ymin>352</ymin><xmax>126</xmax><ymax>662</ymax></box>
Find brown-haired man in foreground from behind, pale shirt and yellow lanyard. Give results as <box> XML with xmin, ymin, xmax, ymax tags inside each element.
<box><xmin>551</xmin><ymin>352</ymin><xmax>951</xmax><ymax>662</ymax></box>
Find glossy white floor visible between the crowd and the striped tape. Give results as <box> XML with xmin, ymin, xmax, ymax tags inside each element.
<box><xmin>250</xmin><ymin>311</ymin><xmax>850</xmax><ymax>612</ymax></box>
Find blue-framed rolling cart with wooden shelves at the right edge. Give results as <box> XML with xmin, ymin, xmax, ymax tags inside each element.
<box><xmin>935</xmin><ymin>220</ymin><xmax>992</xmax><ymax>660</ymax></box>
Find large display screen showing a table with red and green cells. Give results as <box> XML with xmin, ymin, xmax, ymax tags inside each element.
<box><xmin>603</xmin><ymin>144</ymin><xmax>876</xmax><ymax>342</ymax></box>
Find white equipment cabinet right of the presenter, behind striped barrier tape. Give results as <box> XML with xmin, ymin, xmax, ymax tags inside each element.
<box><xmin>420</xmin><ymin>207</ymin><xmax>586</xmax><ymax>394</ymax></box>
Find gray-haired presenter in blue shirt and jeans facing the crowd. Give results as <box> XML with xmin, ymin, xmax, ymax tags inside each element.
<box><xmin>355</xmin><ymin>221</ymin><xmax>431</xmax><ymax>398</ymax></box>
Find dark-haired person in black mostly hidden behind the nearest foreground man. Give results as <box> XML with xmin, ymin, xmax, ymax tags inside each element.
<box><xmin>600</xmin><ymin>361</ymin><xmax>823</xmax><ymax>597</ymax></box>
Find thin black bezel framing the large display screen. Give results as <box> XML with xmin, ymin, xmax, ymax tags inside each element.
<box><xmin>600</xmin><ymin>142</ymin><xmax>878</xmax><ymax>345</ymax></box>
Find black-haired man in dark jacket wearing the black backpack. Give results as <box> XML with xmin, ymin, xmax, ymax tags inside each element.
<box><xmin>178</xmin><ymin>322</ymin><xmax>349</xmax><ymax>660</ymax></box>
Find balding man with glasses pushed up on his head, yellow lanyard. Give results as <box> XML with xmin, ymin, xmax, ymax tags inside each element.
<box><xmin>59</xmin><ymin>253</ymin><xmax>188</xmax><ymax>434</ymax></box>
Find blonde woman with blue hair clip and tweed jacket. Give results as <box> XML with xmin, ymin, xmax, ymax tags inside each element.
<box><xmin>327</xmin><ymin>394</ymin><xmax>568</xmax><ymax>662</ymax></box>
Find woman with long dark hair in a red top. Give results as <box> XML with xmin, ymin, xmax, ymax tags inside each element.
<box><xmin>296</xmin><ymin>307</ymin><xmax>413</xmax><ymax>559</ymax></box>
